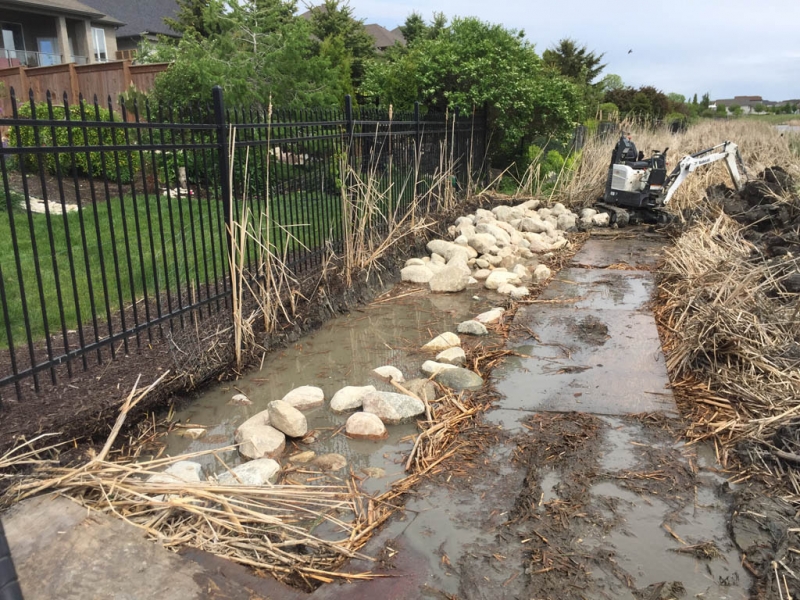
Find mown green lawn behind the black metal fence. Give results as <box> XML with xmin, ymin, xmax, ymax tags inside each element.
<box><xmin>0</xmin><ymin>188</ymin><xmax>350</xmax><ymax>347</ymax></box>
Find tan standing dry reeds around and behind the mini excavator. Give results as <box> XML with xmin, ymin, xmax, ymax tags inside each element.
<box><xmin>553</xmin><ymin>119</ymin><xmax>800</xmax><ymax>212</ymax></box>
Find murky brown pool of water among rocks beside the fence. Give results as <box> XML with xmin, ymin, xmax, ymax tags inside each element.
<box><xmin>160</xmin><ymin>287</ymin><xmax>499</xmax><ymax>491</ymax></box>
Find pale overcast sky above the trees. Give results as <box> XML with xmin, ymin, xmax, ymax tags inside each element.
<box><xmin>350</xmin><ymin>0</ymin><xmax>800</xmax><ymax>100</ymax></box>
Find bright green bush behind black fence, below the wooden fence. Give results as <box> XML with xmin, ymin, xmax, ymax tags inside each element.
<box><xmin>10</xmin><ymin>103</ymin><xmax>139</xmax><ymax>183</ymax></box>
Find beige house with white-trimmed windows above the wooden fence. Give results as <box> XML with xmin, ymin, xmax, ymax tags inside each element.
<box><xmin>0</xmin><ymin>0</ymin><xmax>124</xmax><ymax>68</ymax></box>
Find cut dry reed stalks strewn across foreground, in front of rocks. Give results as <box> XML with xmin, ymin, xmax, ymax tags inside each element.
<box><xmin>0</xmin><ymin>366</ymin><xmax>486</xmax><ymax>591</ymax></box>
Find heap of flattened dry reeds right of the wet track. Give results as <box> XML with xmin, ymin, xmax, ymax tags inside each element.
<box><xmin>656</xmin><ymin>207</ymin><xmax>800</xmax><ymax>504</ymax></box>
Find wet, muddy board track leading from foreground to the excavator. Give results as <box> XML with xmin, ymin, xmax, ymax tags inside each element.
<box><xmin>314</xmin><ymin>238</ymin><xmax>751</xmax><ymax>600</ymax></box>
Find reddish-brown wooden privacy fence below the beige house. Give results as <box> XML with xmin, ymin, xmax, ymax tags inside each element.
<box><xmin>0</xmin><ymin>60</ymin><xmax>169</xmax><ymax>115</ymax></box>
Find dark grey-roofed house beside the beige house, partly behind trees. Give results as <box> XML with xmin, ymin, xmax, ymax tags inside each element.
<box><xmin>83</xmin><ymin>0</ymin><xmax>180</xmax><ymax>60</ymax></box>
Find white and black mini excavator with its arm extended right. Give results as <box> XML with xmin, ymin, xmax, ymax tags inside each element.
<box><xmin>594</xmin><ymin>134</ymin><xmax>747</xmax><ymax>227</ymax></box>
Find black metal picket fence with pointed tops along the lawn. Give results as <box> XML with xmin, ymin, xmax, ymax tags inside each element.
<box><xmin>0</xmin><ymin>88</ymin><xmax>486</xmax><ymax>397</ymax></box>
